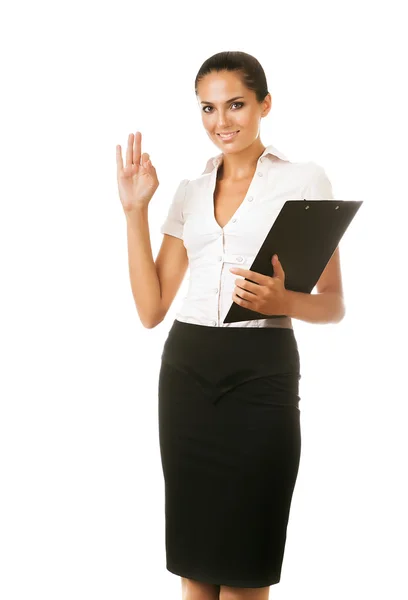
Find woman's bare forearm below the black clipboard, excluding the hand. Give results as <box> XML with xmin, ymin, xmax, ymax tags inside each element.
<box><xmin>285</xmin><ymin>290</ymin><xmax>346</xmax><ymax>323</ymax></box>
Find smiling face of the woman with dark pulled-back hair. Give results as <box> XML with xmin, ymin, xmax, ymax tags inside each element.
<box><xmin>197</xmin><ymin>71</ymin><xmax>271</xmax><ymax>154</ymax></box>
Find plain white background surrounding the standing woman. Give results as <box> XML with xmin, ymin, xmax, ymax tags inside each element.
<box><xmin>0</xmin><ymin>0</ymin><xmax>408</xmax><ymax>600</ymax></box>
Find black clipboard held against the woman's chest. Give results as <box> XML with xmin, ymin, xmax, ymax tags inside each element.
<box><xmin>223</xmin><ymin>199</ymin><xmax>363</xmax><ymax>323</ymax></box>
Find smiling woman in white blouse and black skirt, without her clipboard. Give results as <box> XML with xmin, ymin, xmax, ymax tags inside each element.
<box><xmin>117</xmin><ymin>52</ymin><xmax>344</xmax><ymax>600</ymax></box>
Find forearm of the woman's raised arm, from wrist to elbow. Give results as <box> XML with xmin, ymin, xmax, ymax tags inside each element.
<box><xmin>125</xmin><ymin>207</ymin><xmax>161</xmax><ymax>328</ymax></box>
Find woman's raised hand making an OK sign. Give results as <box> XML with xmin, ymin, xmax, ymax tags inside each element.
<box><xmin>116</xmin><ymin>131</ymin><xmax>159</xmax><ymax>213</ymax></box>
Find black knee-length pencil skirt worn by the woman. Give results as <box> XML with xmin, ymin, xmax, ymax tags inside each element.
<box><xmin>158</xmin><ymin>319</ymin><xmax>301</xmax><ymax>587</ymax></box>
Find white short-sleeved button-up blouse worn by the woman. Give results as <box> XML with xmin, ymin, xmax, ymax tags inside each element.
<box><xmin>160</xmin><ymin>145</ymin><xmax>334</xmax><ymax>329</ymax></box>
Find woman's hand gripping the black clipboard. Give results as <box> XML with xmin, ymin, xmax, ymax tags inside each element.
<box><xmin>230</xmin><ymin>254</ymin><xmax>289</xmax><ymax>315</ymax></box>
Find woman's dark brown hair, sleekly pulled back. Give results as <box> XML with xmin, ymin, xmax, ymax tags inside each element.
<box><xmin>194</xmin><ymin>51</ymin><xmax>269</xmax><ymax>102</ymax></box>
